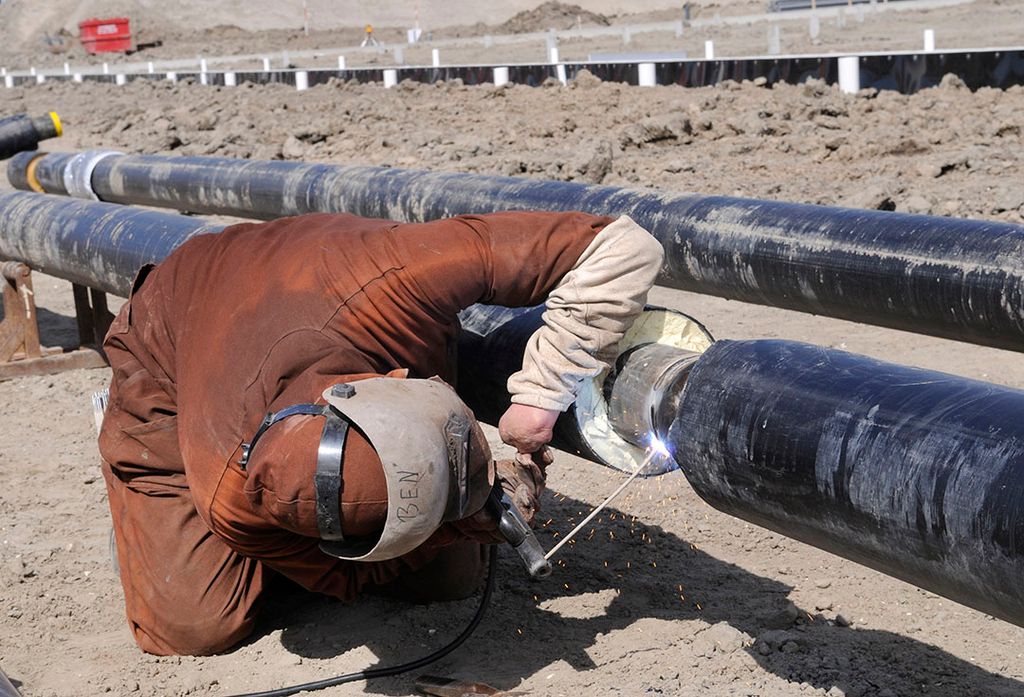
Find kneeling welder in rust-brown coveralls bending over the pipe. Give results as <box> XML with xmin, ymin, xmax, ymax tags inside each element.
<box><xmin>99</xmin><ymin>212</ymin><xmax>663</xmax><ymax>654</ymax></box>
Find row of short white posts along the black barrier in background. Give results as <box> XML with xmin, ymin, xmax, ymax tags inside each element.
<box><xmin>0</xmin><ymin>29</ymin><xmax>935</xmax><ymax>94</ymax></box>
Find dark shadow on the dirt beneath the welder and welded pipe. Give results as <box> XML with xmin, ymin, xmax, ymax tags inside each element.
<box><xmin>247</xmin><ymin>494</ymin><xmax>1024</xmax><ymax>695</ymax></box>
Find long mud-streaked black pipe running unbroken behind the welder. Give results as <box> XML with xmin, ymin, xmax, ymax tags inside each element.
<box><xmin>8</xmin><ymin>154</ymin><xmax>1024</xmax><ymax>351</ymax></box>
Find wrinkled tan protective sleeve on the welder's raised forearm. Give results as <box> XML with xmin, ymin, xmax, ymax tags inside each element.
<box><xmin>508</xmin><ymin>216</ymin><xmax>665</xmax><ymax>411</ymax></box>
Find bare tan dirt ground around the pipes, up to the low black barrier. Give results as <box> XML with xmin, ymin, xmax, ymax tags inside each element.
<box><xmin>0</xmin><ymin>39</ymin><xmax>1024</xmax><ymax>697</ymax></box>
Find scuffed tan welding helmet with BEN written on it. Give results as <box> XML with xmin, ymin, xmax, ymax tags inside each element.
<box><xmin>316</xmin><ymin>378</ymin><xmax>495</xmax><ymax>562</ymax></box>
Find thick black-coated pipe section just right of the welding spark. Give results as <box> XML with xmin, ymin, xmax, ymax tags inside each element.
<box><xmin>667</xmin><ymin>341</ymin><xmax>1024</xmax><ymax>625</ymax></box>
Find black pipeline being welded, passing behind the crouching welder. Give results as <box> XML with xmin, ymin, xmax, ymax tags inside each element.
<box><xmin>6</xmin><ymin>192</ymin><xmax>1024</xmax><ymax>625</ymax></box>
